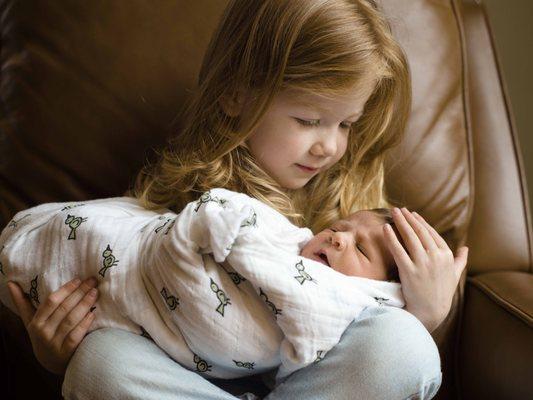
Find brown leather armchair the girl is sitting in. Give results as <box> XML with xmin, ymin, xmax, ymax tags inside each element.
<box><xmin>0</xmin><ymin>0</ymin><xmax>533</xmax><ymax>399</ymax></box>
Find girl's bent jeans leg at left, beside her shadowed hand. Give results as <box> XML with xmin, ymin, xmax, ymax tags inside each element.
<box><xmin>62</xmin><ymin>328</ymin><xmax>236</xmax><ymax>400</ymax></box>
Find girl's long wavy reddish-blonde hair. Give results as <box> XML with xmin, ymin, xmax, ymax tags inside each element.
<box><xmin>133</xmin><ymin>0</ymin><xmax>411</xmax><ymax>232</ymax></box>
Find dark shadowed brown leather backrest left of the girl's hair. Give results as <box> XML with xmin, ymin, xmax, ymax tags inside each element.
<box><xmin>0</xmin><ymin>0</ymin><xmax>225</xmax><ymax>219</ymax></box>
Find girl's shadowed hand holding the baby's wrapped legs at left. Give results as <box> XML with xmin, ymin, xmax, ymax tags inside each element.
<box><xmin>7</xmin><ymin>278</ymin><xmax>97</xmax><ymax>375</ymax></box>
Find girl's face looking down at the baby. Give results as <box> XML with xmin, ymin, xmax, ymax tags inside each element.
<box><xmin>248</xmin><ymin>81</ymin><xmax>374</xmax><ymax>189</ymax></box>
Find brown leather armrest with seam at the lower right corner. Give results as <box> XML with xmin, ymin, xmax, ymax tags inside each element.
<box><xmin>458</xmin><ymin>272</ymin><xmax>533</xmax><ymax>400</ymax></box>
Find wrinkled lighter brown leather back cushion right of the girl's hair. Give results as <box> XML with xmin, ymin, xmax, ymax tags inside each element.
<box><xmin>380</xmin><ymin>0</ymin><xmax>473</xmax><ymax>255</ymax></box>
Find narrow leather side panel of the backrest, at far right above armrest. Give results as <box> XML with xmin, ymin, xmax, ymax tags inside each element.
<box><xmin>462</xmin><ymin>0</ymin><xmax>533</xmax><ymax>275</ymax></box>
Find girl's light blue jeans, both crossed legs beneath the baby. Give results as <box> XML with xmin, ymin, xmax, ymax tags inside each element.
<box><xmin>62</xmin><ymin>307</ymin><xmax>442</xmax><ymax>400</ymax></box>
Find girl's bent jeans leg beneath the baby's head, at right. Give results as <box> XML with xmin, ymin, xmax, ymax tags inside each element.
<box><xmin>267</xmin><ymin>307</ymin><xmax>442</xmax><ymax>400</ymax></box>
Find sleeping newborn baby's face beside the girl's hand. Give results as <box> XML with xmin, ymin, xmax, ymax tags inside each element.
<box><xmin>301</xmin><ymin>211</ymin><xmax>394</xmax><ymax>280</ymax></box>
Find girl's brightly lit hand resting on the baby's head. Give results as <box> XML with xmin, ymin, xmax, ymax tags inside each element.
<box><xmin>383</xmin><ymin>208</ymin><xmax>468</xmax><ymax>332</ymax></box>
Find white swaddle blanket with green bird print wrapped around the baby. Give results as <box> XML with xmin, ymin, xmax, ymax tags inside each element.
<box><xmin>0</xmin><ymin>189</ymin><xmax>404</xmax><ymax>381</ymax></box>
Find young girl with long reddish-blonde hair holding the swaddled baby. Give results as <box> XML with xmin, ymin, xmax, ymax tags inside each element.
<box><xmin>10</xmin><ymin>0</ymin><xmax>467</xmax><ymax>399</ymax></box>
